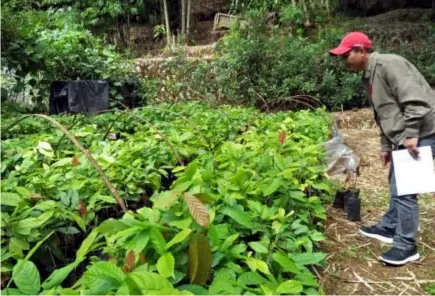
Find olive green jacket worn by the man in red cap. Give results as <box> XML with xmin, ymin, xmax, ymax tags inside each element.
<box><xmin>363</xmin><ymin>52</ymin><xmax>435</xmax><ymax>151</ymax></box>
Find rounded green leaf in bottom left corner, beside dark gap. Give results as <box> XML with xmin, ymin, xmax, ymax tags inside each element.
<box><xmin>12</xmin><ymin>260</ymin><xmax>41</xmax><ymax>295</ymax></box>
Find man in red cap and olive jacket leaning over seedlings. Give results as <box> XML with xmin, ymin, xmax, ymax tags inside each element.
<box><xmin>330</xmin><ymin>32</ymin><xmax>435</xmax><ymax>265</ymax></box>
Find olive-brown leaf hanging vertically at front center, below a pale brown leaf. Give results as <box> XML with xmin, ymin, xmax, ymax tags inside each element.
<box><xmin>189</xmin><ymin>234</ymin><xmax>212</xmax><ymax>285</ymax></box>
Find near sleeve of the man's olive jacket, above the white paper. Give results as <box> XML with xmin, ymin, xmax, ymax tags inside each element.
<box><xmin>385</xmin><ymin>60</ymin><xmax>431</xmax><ymax>138</ymax></box>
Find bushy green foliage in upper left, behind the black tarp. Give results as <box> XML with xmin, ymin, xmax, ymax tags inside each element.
<box><xmin>2</xmin><ymin>3</ymin><xmax>133</xmax><ymax>110</ymax></box>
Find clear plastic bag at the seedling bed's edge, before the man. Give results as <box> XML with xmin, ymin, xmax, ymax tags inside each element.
<box><xmin>325</xmin><ymin>125</ymin><xmax>360</xmax><ymax>181</ymax></box>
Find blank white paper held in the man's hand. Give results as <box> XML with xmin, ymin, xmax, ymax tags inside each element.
<box><xmin>393</xmin><ymin>146</ymin><xmax>435</xmax><ymax>196</ymax></box>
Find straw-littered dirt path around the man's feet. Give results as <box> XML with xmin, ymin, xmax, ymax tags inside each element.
<box><xmin>321</xmin><ymin>113</ymin><xmax>435</xmax><ymax>295</ymax></box>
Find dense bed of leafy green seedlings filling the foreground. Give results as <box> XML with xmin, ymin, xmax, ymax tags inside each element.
<box><xmin>1</xmin><ymin>103</ymin><xmax>331</xmax><ymax>295</ymax></box>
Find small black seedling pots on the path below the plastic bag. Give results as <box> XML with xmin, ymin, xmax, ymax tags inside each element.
<box><xmin>333</xmin><ymin>189</ymin><xmax>361</xmax><ymax>221</ymax></box>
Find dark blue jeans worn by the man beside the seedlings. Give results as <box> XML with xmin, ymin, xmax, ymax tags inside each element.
<box><xmin>376</xmin><ymin>136</ymin><xmax>435</xmax><ymax>250</ymax></box>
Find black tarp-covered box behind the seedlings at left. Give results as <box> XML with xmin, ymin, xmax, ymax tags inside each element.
<box><xmin>50</xmin><ymin>80</ymin><xmax>109</xmax><ymax>114</ymax></box>
